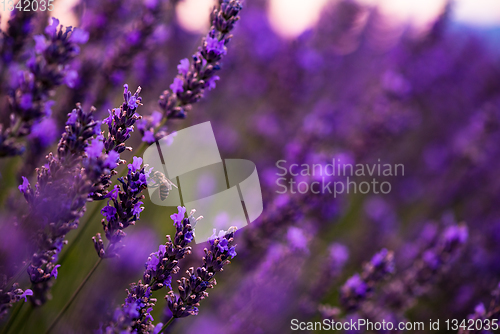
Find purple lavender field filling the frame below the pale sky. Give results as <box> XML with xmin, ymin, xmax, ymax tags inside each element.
<box><xmin>0</xmin><ymin>0</ymin><xmax>500</xmax><ymax>334</ymax></box>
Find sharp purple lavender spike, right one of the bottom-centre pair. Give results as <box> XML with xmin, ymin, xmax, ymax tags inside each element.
<box><xmin>165</xmin><ymin>228</ymin><xmax>236</xmax><ymax>318</ymax></box>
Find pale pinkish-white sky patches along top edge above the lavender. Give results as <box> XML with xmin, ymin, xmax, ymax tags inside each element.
<box><xmin>0</xmin><ymin>0</ymin><xmax>500</xmax><ymax>37</ymax></box>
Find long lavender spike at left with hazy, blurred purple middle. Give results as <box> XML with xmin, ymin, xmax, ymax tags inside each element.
<box><xmin>19</xmin><ymin>106</ymin><xmax>104</xmax><ymax>304</ymax></box>
